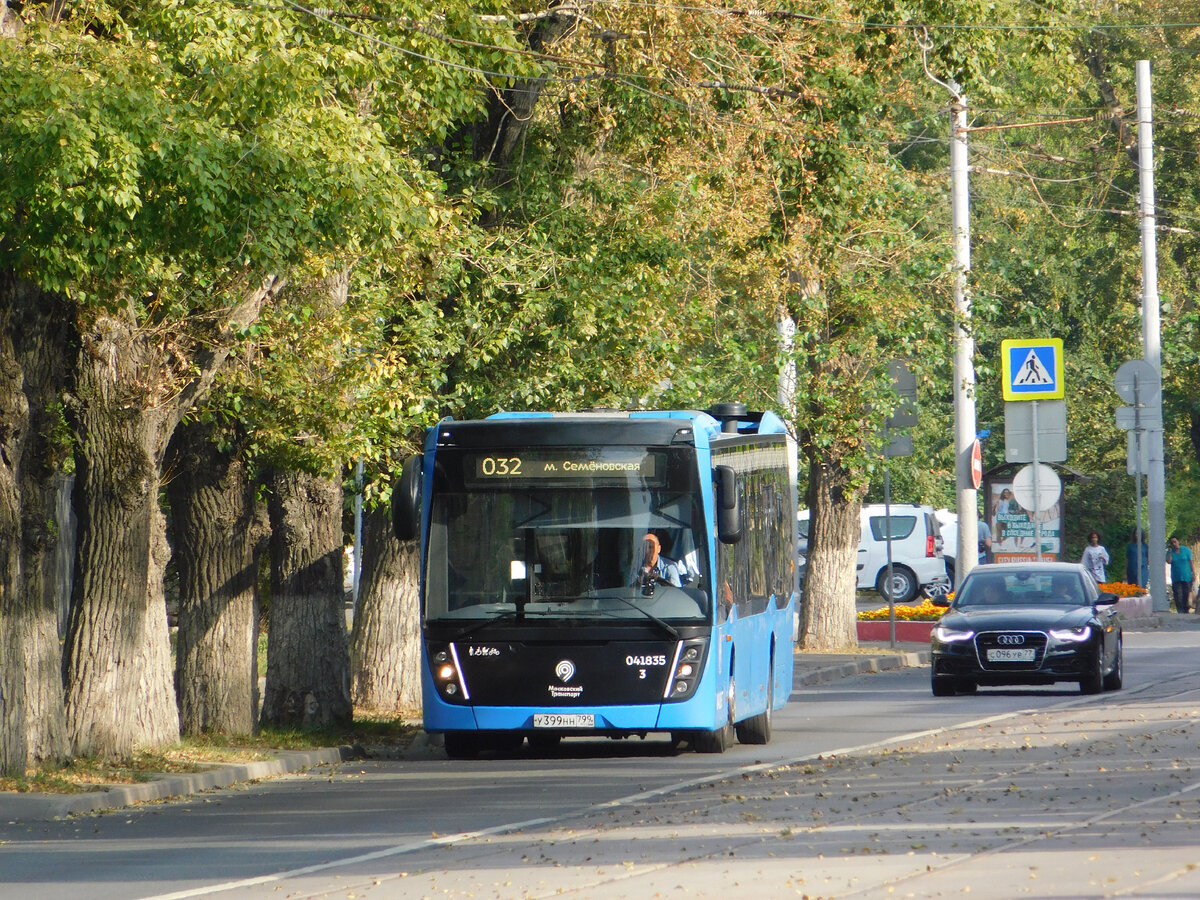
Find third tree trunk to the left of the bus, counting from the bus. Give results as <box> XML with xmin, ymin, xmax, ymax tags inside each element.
<box><xmin>167</xmin><ymin>422</ymin><xmax>268</xmax><ymax>734</ymax></box>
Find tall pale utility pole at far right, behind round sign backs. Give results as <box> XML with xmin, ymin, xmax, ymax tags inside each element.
<box><xmin>1138</xmin><ymin>60</ymin><xmax>1170</xmax><ymax>612</ymax></box>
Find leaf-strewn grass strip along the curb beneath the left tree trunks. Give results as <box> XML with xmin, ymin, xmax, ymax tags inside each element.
<box><xmin>0</xmin><ymin>716</ymin><xmax>421</xmax><ymax>793</ymax></box>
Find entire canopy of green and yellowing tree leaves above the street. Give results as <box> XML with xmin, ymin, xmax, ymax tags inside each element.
<box><xmin>7</xmin><ymin>0</ymin><xmax>1200</xmax><ymax>540</ymax></box>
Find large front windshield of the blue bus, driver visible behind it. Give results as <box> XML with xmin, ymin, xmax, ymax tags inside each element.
<box><xmin>425</xmin><ymin>451</ymin><xmax>710</xmax><ymax>623</ymax></box>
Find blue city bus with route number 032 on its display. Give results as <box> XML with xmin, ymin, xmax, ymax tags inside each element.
<box><xmin>392</xmin><ymin>403</ymin><xmax>798</xmax><ymax>758</ymax></box>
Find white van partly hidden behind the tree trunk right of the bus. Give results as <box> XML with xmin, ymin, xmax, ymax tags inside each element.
<box><xmin>799</xmin><ymin>503</ymin><xmax>949</xmax><ymax>604</ymax></box>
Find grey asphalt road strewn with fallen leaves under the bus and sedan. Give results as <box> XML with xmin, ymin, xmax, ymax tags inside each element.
<box><xmin>7</xmin><ymin>629</ymin><xmax>1200</xmax><ymax>900</ymax></box>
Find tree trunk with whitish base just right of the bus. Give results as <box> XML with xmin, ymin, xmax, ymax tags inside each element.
<box><xmin>800</xmin><ymin>455</ymin><xmax>863</xmax><ymax>650</ymax></box>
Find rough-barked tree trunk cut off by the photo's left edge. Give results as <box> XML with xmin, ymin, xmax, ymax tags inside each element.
<box><xmin>0</xmin><ymin>276</ymin><xmax>67</xmax><ymax>772</ymax></box>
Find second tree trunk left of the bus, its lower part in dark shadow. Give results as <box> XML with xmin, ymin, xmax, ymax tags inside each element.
<box><xmin>262</xmin><ymin>472</ymin><xmax>354</xmax><ymax>728</ymax></box>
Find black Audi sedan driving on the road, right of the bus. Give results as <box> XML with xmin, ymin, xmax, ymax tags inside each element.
<box><xmin>930</xmin><ymin>563</ymin><xmax>1123</xmax><ymax>697</ymax></box>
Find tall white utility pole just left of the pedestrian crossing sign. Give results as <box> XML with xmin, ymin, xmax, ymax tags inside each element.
<box><xmin>947</xmin><ymin>93</ymin><xmax>979</xmax><ymax>584</ymax></box>
